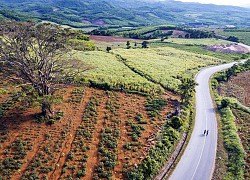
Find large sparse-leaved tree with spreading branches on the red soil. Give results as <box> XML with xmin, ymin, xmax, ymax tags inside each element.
<box><xmin>0</xmin><ymin>21</ymin><xmax>88</xmax><ymax>118</ymax></box>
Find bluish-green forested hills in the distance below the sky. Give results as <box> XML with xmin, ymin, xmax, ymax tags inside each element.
<box><xmin>0</xmin><ymin>0</ymin><xmax>250</xmax><ymax>27</ymax></box>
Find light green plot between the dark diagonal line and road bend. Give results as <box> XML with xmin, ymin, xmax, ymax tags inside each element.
<box><xmin>112</xmin><ymin>47</ymin><xmax>220</xmax><ymax>90</ymax></box>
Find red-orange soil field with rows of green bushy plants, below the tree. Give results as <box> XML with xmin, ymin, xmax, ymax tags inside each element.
<box><xmin>0</xmin><ymin>81</ymin><xmax>177</xmax><ymax>179</ymax></box>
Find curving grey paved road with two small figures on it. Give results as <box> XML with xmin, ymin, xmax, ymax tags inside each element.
<box><xmin>170</xmin><ymin>63</ymin><xmax>234</xmax><ymax>180</ymax></box>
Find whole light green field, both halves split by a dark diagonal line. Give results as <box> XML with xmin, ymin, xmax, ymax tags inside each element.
<box><xmin>75</xmin><ymin>47</ymin><xmax>220</xmax><ymax>93</ymax></box>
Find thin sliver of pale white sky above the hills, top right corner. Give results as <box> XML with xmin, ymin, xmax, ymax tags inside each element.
<box><xmin>178</xmin><ymin>0</ymin><xmax>250</xmax><ymax>6</ymax></box>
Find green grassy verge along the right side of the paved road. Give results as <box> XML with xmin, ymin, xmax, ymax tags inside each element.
<box><xmin>211</xmin><ymin>67</ymin><xmax>250</xmax><ymax>179</ymax></box>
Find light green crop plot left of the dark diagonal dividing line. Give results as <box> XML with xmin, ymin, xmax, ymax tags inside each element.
<box><xmin>75</xmin><ymin>51</ymin><xmax>163</xmax><ymax>93</ymax></box>
